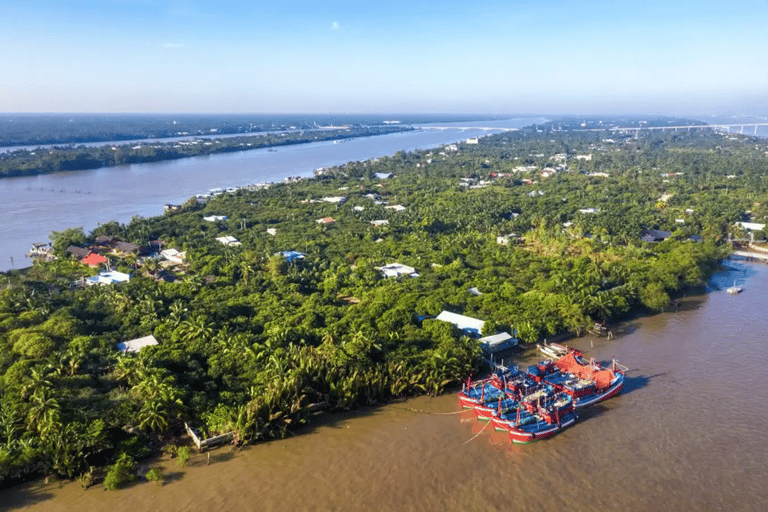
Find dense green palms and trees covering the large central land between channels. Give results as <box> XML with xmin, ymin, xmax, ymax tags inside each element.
<box><xmin>0</xmin><ymin>123</ymin><xmax>768</xmax><ymax>486</ymax></box>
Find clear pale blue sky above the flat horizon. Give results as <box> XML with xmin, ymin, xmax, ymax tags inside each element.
<box><xmin>0</xmin><ymin>0</ymin><xmax>768</xmax><ymax>115</ymax></box>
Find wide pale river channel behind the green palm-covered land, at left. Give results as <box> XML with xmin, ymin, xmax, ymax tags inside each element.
<box><xmin>0</xmin><ymin>118</ymin><xmax>544</xmax><ymax>271</ymax></box>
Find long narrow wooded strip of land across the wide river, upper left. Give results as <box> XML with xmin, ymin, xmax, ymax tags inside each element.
<box><xmin>0</xmin><ymin>125</ymin><xmax>412</xmax><ymax>178</ymax></box>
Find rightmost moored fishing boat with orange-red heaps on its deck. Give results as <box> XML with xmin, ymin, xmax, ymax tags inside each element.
<box><xmin>544</xmin><ymin>354</ymin><xmax>627</xmax><ymax>409</ymax></box>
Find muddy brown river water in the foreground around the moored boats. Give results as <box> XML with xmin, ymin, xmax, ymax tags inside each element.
<box><xmin>0</xmin><ymin>261</ymin><xmax>768</xmax><ymax>512</ymax></box>
